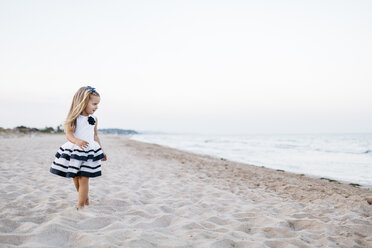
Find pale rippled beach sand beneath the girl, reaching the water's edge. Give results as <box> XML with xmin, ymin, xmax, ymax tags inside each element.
<box><xmin>0</xmin><ymin>135</ymin><xmax>372</xmax><ymax>248</ymax></box>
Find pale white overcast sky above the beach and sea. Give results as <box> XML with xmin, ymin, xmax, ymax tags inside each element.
<box><xmin>0</xmin><ymin>0</ymin><xmax>372</xmax><ymax>134</ymax></box>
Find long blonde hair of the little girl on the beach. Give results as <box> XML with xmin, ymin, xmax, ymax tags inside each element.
<box><xmin>65</xmin><ymin>86</ymin><xmax>100</xmax><ymax>131</ymax></box>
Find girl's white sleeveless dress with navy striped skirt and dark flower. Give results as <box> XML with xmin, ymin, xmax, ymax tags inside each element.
<box><xmin>50</xmin><ymin>115</ymin><xmax>104</xmax><ymax>177</ymax></box>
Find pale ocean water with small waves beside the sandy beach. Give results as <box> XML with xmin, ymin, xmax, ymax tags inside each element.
<box><xmin>131</xmin><ymin>133</ymin><xmax>372</xmax><ymax>188</ymax></box>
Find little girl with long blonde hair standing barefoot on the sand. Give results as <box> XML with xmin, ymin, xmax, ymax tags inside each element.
<box><xmin>50</xmin><ymin>86</ymin><xmax>107</xmax><ymax>210</ymax></box>
